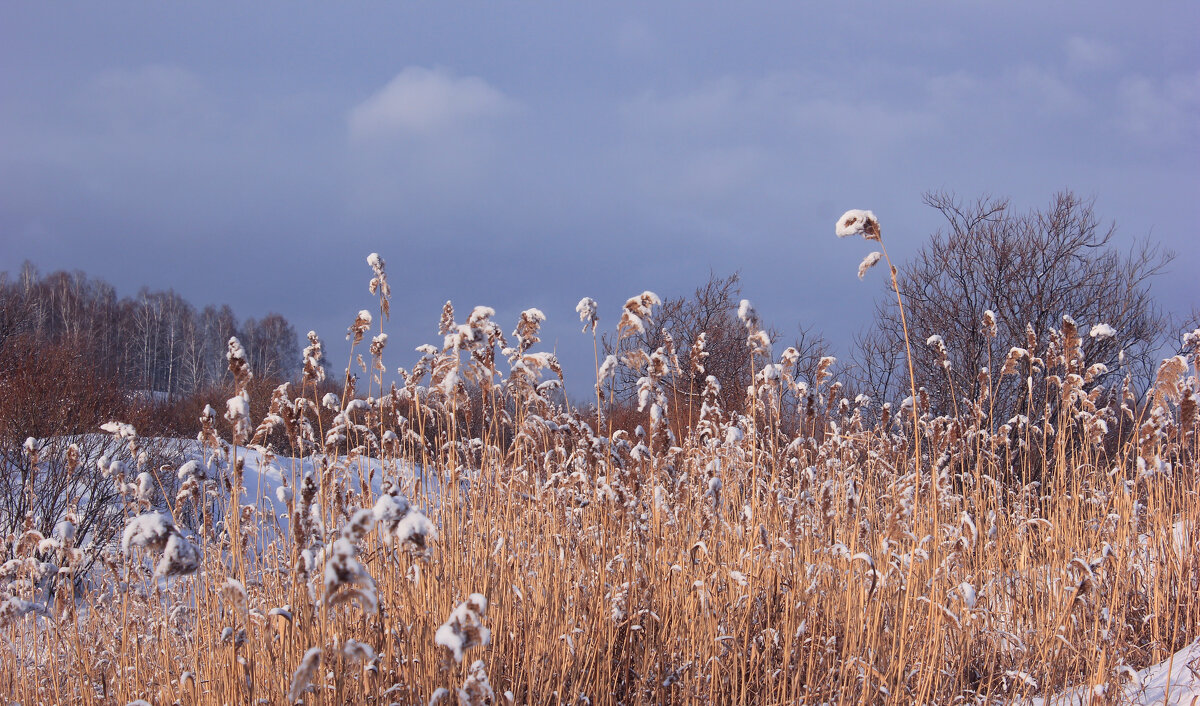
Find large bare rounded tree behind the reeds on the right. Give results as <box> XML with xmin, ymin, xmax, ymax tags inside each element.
<box><xmin>854</xmin><ymin>192</ymin><xmax>1172</xmax><ymax>415</ymax></box>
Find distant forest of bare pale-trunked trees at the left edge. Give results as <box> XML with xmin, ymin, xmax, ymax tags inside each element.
<box><xmin>0</xmin><ymin>262</ymin><xmax>300</xmax><ymax>401</ymax></box>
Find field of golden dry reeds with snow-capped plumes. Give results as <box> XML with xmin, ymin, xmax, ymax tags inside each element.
<box><xmin>0</xmin><ymin>241</ymin><xmax>1200</xmax><ymax>704</ymax></box>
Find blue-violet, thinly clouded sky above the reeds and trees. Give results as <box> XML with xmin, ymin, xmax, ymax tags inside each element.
<box><xmin>0</xmin><ymin>0</ymin><xmax>1200</xmax><ymax>390</ymax></box>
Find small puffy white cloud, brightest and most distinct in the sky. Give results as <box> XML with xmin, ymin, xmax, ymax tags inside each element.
<box><xmin>348</xmin><ymin>66</ymin><xmax>517</xmax><ymax>140</ymax></box>
